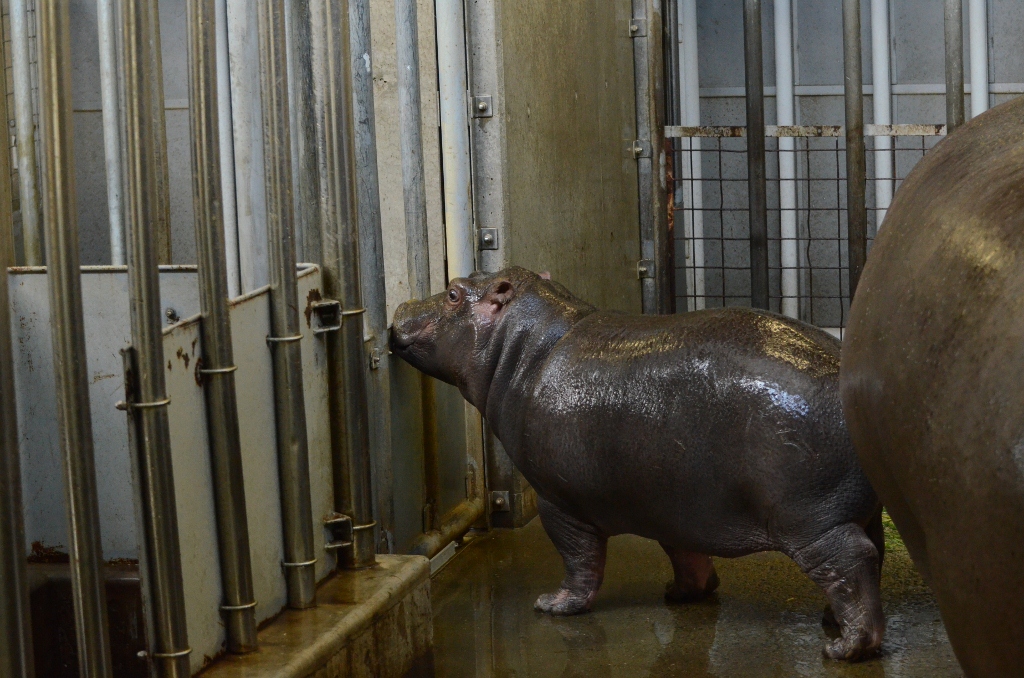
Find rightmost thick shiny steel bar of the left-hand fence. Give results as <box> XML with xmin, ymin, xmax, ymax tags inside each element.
<box><xmin>310</xmin><ymin>0</ymin><xmax>375</xmax><ymax>567</ymax></box>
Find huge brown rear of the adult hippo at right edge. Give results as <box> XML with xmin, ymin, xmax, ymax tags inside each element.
<box><xmin>842</xmin><ymin>98</ymin><xmax>1024</xmax><ymax>677</ymax></box>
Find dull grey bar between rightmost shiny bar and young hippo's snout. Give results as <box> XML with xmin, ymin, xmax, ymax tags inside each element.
<box><xmin>348</xmin><ymin>0</ymin><xmax>394</xmax><ymax>544</ymax></box>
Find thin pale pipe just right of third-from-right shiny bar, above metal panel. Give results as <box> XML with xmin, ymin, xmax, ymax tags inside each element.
<box><xmin>215</xmin><ymin>0</ymin><xmax>242</xmax><ymax>299</ymax></box>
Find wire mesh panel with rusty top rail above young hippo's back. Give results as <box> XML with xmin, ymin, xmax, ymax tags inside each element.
<box><xmin>667</xmin><ymin>125</ymin><xmax>945</xmax><ymax>334</ymax></box>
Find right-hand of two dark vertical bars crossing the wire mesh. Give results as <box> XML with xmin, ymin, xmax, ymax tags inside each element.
<box><xmin>843</xmin><ymin>0</ymin><xmax>868</xmax><ymax>299</ymax></box>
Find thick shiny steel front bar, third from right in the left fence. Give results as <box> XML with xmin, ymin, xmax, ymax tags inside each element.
<box><xmin>185</xmin><ymin>0</ymin><xmax>256</xmax><ymax>653</ymax></box>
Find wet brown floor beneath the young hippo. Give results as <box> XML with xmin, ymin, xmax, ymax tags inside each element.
<box><xmin>431</xmin><ymin>519</ymin><xmax>963</xmax><ymax>678</ymax></box>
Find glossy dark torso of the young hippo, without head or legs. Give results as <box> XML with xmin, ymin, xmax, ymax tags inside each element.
<box><xmin>513</xmin><ymin>313</ymin><xmax>878</xmax><ymax>556</ymax></box>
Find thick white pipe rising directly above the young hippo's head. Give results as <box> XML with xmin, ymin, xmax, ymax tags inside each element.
<box><xmin>435</xmin><ymin>0</ymin><xmax>476</xmax><ymax>280</ymax></box>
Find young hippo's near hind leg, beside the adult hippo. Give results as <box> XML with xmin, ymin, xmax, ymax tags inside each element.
<box><xmin>790</xmin><ymin>522</ymin><xmax>885</xmax><ymax>661</ymax></box>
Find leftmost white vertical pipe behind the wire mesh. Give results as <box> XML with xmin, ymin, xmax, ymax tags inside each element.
<box><xmin>678</xmin><ymin>0</ymin><xmax>706</xmax><ymax>310</ymax></box>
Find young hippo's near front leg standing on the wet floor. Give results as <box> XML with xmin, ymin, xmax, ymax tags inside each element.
<box><xmin>534</xmin><ymin>497</ymin><xmax>608</xmax><ymax>615</ymax></box>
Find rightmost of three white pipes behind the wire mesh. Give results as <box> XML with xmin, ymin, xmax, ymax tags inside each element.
<box><xmin>871</xmin><ymin>0</ymin><xmax>893</xmax><ymax>232</ymax></box>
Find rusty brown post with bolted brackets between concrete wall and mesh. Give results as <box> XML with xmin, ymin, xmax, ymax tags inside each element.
<box><xmin>630</xmin><ymin>0</ymin><xmax>675</xmax><ymax>313</ymax></box>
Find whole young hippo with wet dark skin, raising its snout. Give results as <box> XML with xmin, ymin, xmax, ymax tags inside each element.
<box><xmin>391</xmin><ymin>268</ymin><xmax>885</xmax><ymax>660</ymax></box>
